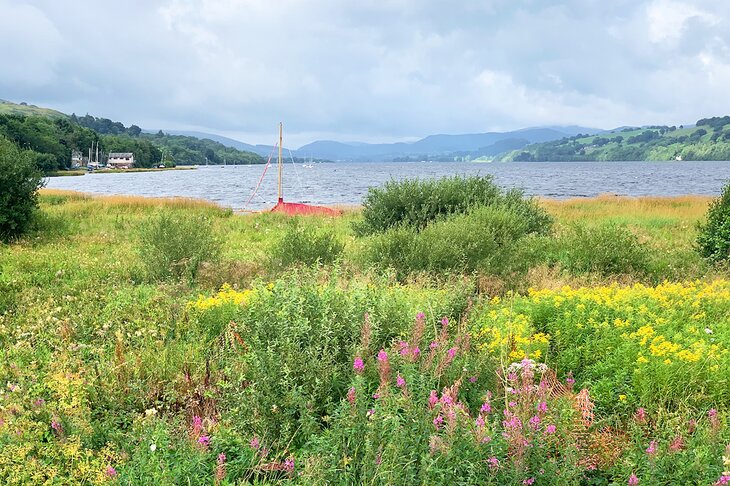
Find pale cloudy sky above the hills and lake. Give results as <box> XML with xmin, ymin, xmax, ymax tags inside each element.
<box><xmin>0</xmin><ymin>0</ymin><xmax>730</xmax><ymax>146</ymax></box>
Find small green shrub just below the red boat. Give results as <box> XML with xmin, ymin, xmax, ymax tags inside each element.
<box><xmin>272</xmin><ymin>218</ymin><xmax>344</xmax><ymax>267</ymax></box>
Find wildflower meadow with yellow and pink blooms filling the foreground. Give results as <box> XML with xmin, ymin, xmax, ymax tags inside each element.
<box><xmin>0</xmin><ymin>184</ymin><xmax>730</xmax><ymax>485</ymax></box>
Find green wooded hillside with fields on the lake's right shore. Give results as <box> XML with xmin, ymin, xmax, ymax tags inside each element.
<box><xmin>495</xmin><ymin>116</ymin><xmax>730</xmax><ymax>162</ymax></box>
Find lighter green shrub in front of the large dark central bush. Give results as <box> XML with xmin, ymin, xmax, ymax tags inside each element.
<box><xmin>368</xmin><ymin>206</ymin><xmax>529</xmax><ymax>278</ymax></box>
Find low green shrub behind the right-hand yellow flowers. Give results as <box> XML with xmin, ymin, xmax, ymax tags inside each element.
<box><xmin>547</xmin><ymin>224</ymin><xmax>651</xmax><ymax>277</ymax></box>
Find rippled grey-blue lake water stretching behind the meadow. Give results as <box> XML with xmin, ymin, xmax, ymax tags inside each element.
<box><xmin>47</xmin><ymin>162</ymin><xmax>730</xmax><ymax>209</ymax></box>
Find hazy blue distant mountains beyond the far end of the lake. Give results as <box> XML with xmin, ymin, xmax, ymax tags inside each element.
<box><xmin>296</xmin><ymin>126</ymin><xmax>601</xmax><ymax>161</ymax></box>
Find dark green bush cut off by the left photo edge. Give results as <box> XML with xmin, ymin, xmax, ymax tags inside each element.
<box><xmin>0</xmin><ymin>138</ymin><xmax>44</xmax><ymax>241</ymax></box>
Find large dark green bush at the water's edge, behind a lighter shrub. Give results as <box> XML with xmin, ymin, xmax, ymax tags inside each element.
<box><xmin>354</xmin><ymin>176</ymin><xmax>552</xmax><ymax>236</ymax></box>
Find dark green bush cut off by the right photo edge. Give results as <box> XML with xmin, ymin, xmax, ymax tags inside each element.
<box><xmin>697</xmin><ymin>180</ymin><xmax>730</xmax><ymax>263</ymax></box>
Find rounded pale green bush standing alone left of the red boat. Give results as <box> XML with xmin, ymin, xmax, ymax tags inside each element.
<box><xmin>139</xmin><ymin>211</ymin><xmax>221</xmax><ymax>281</ymax></box>
